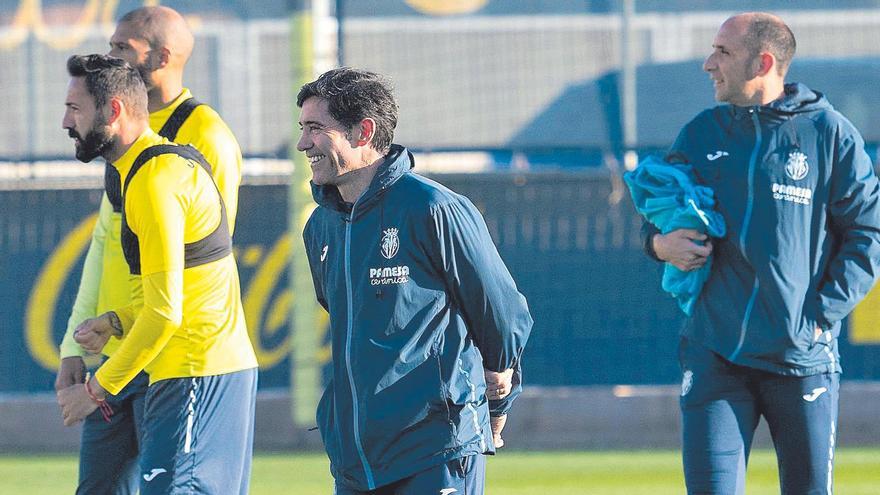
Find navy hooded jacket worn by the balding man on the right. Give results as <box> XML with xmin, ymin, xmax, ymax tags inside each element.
<box><xmin>648</xmin><ymin>84</ymin><xmax>880</xmax><ymax>376</ymax></box>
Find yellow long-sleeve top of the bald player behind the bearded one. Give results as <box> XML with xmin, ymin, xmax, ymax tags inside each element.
<box><xmin>61</xmin><ymin>89</ymin><xmax>242</xmax><ymax>358</ymax></box>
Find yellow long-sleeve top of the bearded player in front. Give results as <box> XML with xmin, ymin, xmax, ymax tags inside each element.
<box><xmin>95</xmin><ymin>130</ymin><xmax>257</xmax><ymax>394</ymax></box>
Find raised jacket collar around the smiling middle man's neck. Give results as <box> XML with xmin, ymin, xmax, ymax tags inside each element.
<box><xmin>309</xmin><ymin>144</ymin><xmax>415</xmax><ymax>216</ymax></box>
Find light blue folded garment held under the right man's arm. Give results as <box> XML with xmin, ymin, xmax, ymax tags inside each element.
<box><xmin>623</xmin><ymin>156</ymin><xmax>727</xmax><ymax>316</ymax></box>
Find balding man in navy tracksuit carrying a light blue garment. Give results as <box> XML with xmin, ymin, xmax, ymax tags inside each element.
<box><xmin>646</xmin><ymin>13</ymin><xmax>880</xmax><ymax>494</ymax></box>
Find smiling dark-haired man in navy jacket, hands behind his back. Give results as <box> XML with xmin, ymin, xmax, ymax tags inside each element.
<box><xmin>297</xmin><ymin>68</ymin><xmax>532</xmax><ymax>495</ymax></box>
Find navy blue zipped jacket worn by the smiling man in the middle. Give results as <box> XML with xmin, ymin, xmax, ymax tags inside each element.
<box><xmin>303</xmin><ymin>145</ymin><xmax>532</xmax><ymax>490</ymax></box>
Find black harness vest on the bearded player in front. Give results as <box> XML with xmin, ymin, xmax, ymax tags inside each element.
<box><xmin>121</xmin><ymin>144</ymin><xmax>232</xmax><ymax>275</ymax></box>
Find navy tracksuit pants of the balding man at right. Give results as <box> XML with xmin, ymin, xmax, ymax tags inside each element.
<box><xmin>679</xmin><ymin>338</ymin><xmax>840</xmax><ymax>495</ymax></box>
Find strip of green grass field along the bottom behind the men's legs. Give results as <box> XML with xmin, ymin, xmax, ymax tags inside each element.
<box><xmin>0</xmin><ymin>449</ymin><xmax>880</xmax><ymax>495</ymax></box>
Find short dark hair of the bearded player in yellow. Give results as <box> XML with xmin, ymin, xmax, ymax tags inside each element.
<box><xmin>67</xmin><ymin>54</ymin><xmax>149</xmax><ymax>117</ymax></box>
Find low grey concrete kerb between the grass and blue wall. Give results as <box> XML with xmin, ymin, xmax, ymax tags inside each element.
<box><xmin>0</xmin><ymin>381</ymin><xmax>880</xmax><ymax>454</ymax></box>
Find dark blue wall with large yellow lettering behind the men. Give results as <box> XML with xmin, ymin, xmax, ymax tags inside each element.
<box><xmin>0</xmin><ymin>173</ymin><xmax>880</xmax><ymax>392</ymax></box>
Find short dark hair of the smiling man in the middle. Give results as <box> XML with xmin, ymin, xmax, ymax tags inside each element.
<box><xmin>296</xmin><ymin>67</ymin><xmax>397</xmax><ymax>153</ymax></box>
